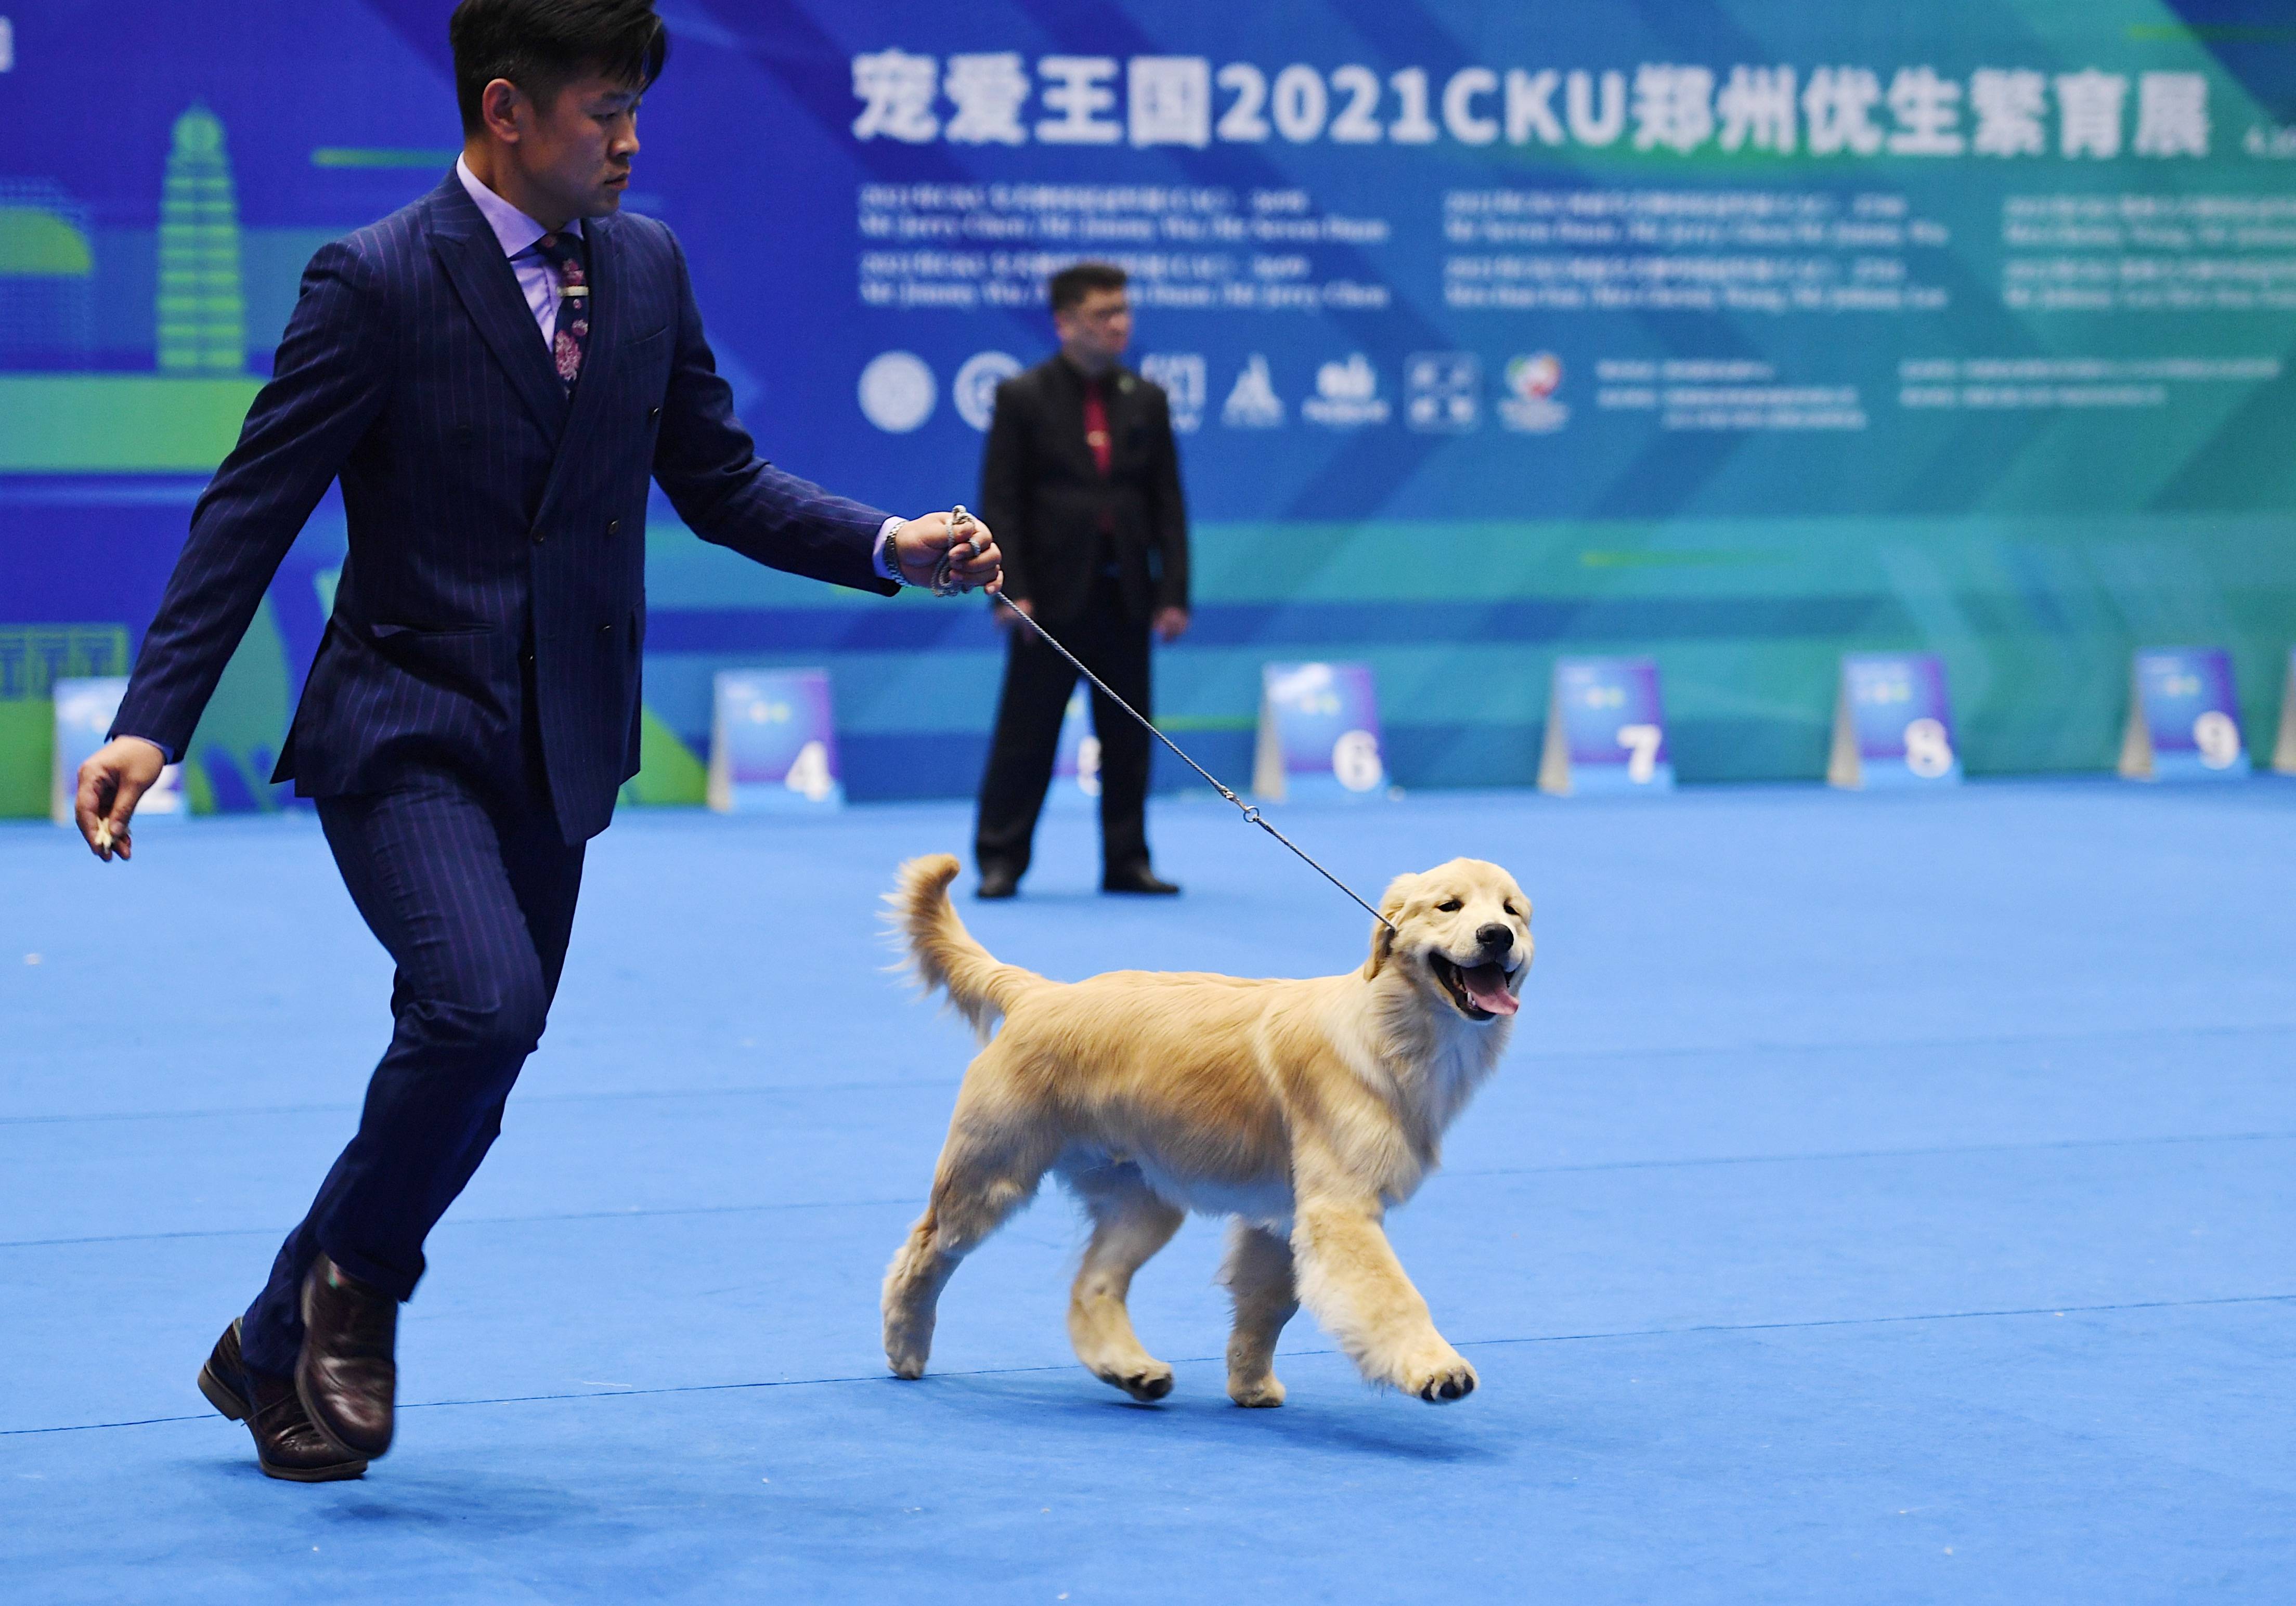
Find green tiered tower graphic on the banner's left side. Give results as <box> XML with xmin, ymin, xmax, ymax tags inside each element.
<box><xmin>159</xmin><ymin>103</ymin><xmax>248</xmax><ymax>374</ymax></box>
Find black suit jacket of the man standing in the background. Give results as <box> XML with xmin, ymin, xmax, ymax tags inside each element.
<box><xmin>980</xmin><ymin>356</ymin><xmax>1187</xmax><ymax>626</ymax></box>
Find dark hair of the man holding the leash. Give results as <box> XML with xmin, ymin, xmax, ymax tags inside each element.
<box><xmin>446</xmin><ymin>0</ymin><xmax>670</xmax><ymax>133</ymax></box>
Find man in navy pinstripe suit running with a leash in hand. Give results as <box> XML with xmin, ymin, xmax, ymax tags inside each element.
<box><xmin>78</xmin><ymin>0</ymin><xmax>999</xmax><ymax>1482</ymax></box>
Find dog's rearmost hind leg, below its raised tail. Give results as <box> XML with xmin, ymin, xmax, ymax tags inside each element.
<box><xmin>884</xmin><ymin>1094</ymin><xmax>1052</xmax><ymax>1377</ymax></box>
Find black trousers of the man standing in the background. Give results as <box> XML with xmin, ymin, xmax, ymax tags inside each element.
<box><xmin>974</xmin><ymin>576</ymin><xmax>1155</xmax><ymax>877</ymax></box>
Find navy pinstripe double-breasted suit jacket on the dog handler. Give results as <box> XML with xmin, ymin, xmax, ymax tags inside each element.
<box><xmin>112</xmin><ymin>174</ymin><xmax>898</xmax><ymax>842</ymax></box>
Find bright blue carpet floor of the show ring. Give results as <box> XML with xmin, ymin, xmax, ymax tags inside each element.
<box><xmin>0</xmin><ymin>780</ymin><xmax>2296</xmax><ymax>1606</ymax></box>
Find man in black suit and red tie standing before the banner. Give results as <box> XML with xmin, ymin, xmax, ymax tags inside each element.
<box><xmin>974</xmin><ymin>262</ymin><xmax>1187</xmax><ymax>897</ymax></box>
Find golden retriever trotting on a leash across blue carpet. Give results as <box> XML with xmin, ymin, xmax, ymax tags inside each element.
<box><xmin>884</xmin><ymin>854</ymin><xmax>1532</xmax><ymax>1406</ymax></box>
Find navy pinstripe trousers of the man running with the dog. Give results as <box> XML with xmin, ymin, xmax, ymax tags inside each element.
<box><xmin>241</xmin><ymin>743</ymin><xmax>583</xmax><ymax>1374</ymax></box>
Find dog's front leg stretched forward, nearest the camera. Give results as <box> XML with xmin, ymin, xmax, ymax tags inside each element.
<box><xmin>1293</xmin><ymin>1193</ymin><xmax>1476</xmax><ymax>1404</ymax></box>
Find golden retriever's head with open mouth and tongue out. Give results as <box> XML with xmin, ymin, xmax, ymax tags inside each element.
<box><xmin>1364</xmin><ymin>858</ymin><xmax>1532</xmax><ymax>1026</ymax></box>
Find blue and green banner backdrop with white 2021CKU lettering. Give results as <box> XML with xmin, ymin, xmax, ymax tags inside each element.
<box><xmin>0</xmin><ymin>0</ymin><xmax>2296</xmax><ymax>807</ymax></box>
